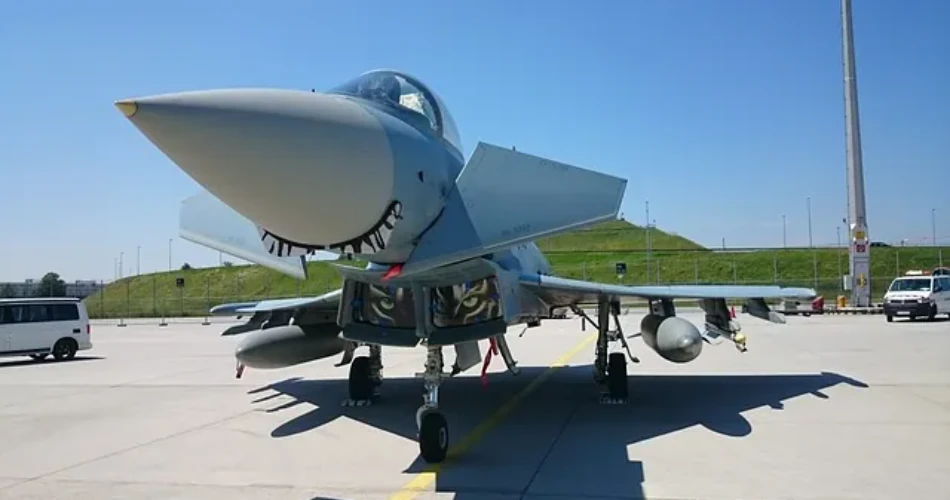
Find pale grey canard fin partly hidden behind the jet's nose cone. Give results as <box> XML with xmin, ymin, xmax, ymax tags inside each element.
<box><xmin>179</xmin><ymin>191</ymin><xmax>307</xmax><ymax>279</ymax></box>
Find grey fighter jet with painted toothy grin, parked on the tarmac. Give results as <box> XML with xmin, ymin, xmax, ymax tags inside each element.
<box><xmin>115</xmin><ymin>70</ymin><xmax>816</xmax><ymax>462</ymax></box>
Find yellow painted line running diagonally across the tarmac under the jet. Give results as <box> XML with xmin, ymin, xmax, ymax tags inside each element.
<box><xmin>389</xmin><ymin>333</ymin><xmax>597</xmax><ymax>500</ymax></box>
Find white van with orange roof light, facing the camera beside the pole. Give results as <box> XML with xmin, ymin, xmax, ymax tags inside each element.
<box><xmin>884</xmin><ymin>271</ymin><xmax>950</xmax><ymax>321</ymax></box>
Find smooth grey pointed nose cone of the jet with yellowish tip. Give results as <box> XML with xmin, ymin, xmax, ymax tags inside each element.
<box><xmin>115</xmin><ymin>89</ymin><xmax>394</xmax><ymax>250</ymax></box>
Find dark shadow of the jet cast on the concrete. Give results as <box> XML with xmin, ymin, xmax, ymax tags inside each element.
<box><xmin>249</xmin><ymin>365</ymin><xmax>868</xmax><ymax>500</ymax></box>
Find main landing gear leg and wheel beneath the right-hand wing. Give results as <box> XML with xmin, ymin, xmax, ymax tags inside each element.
<box><xmin>572</xmin><ymin>298</ymin><xmax>640</xmax><ymax>404</ymax></box>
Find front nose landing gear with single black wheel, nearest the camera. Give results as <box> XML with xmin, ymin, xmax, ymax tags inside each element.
<box><xmin>416</xmin><ymin>347</ymin><xmax>449</xmax><ymax>463</ymax></box>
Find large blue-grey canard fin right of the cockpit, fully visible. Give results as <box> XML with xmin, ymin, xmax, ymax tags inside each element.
<box><xmin>402</xmin><ymin>142</ymin><xmax>627</xmax><ymax>274</ymax></box>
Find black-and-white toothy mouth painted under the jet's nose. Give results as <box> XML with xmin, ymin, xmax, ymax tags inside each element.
<box><xmin>259</xmin><ymin>201</ymin><xmax>402</xmax><ymax>257</ymax></box>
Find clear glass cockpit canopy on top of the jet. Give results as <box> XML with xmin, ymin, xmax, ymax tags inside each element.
<box><xmin>328</xmin><ymin>70</ymin><xmax>462</xmax><ymax>153</ymax></box>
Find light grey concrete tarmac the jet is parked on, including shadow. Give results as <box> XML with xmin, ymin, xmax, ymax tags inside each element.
<box><xmin>0</xmin><ymin>309</ymin><xmax>950</xmax><ymax>500</ymax></box>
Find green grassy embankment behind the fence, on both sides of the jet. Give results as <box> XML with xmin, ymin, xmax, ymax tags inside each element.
<box><xmin>85</xmin><ymin>221</ymin><xmax>950</xmax><ymax>318</ymax></box>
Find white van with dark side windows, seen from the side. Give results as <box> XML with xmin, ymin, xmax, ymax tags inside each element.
<box><xmin>0</xmin><ymin>297</ymin><xmax>92</xmax><ymax>361</ymax></box>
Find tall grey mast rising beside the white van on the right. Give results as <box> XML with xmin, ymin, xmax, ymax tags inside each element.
<box><xmin>841</xmin><ymin>0</ymin><xmax>871</xmax><ymax>307</ymax></box>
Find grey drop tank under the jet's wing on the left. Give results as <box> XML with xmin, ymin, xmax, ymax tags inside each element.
<box><xmin>234</xmin><ymin>323</ymin><xmax>346</xmax><ymax>369</ymax></box>
